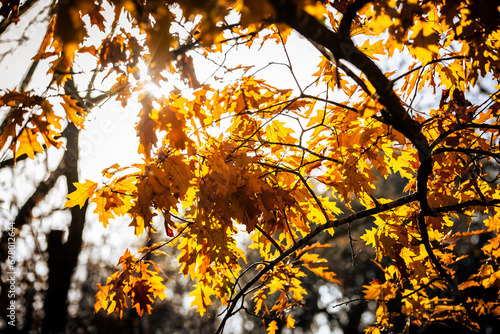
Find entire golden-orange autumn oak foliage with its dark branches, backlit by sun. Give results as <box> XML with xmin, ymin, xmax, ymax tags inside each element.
<box><xmin>0</xmin><ymin>0</ymin><xmax>500</xmax><ymax>333</ymax></box>
